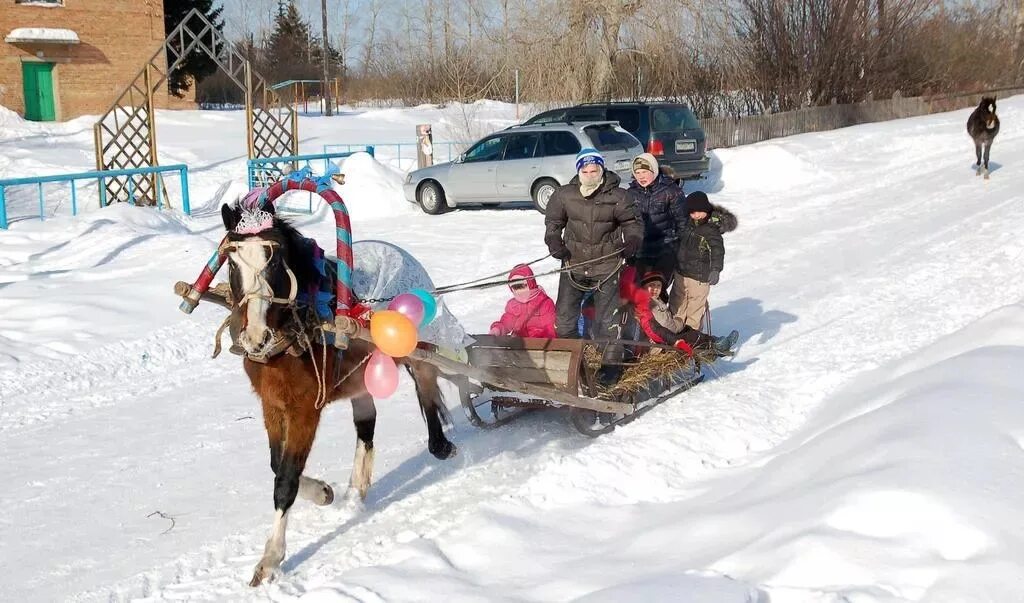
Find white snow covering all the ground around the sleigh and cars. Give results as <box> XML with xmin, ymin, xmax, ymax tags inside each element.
<box><xmin>0</xmin><ymin>97</ymin><xmax>1024</xmax><ymax>603</ymax></box>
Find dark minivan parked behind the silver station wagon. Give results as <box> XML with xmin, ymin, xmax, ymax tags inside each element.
<box><xmin>524</xmin><ymin>102</ymin><xmax>710</xmax><ymax>178</ymax></box>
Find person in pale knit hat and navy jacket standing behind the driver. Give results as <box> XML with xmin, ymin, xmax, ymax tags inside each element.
<box><xmin>629</xmin><ymin>153</ymin><xmax>687</xmax><ymax>284</ymax></box>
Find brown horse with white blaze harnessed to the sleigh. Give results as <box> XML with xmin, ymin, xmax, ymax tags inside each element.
<box><xmin>221</xmin><ymin>204</ymin><xmax>456</xmax><ymax>587</ymax></box>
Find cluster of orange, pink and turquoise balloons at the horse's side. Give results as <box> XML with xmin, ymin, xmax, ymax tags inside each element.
<box><xmin>362</xmin><ymin>289</ymin><xmax>437</xmax><ymax>398</ymax></box>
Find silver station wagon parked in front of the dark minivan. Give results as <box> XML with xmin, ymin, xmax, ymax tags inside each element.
<box><xmin>404</xmin><ymin>122</ymin><xmax>643</xmax><ymax>214</ymax></box>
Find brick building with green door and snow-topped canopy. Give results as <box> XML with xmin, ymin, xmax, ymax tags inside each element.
<box><xmin>0</xmin><ymin>0</ymin><xmax>180</xmax><ymax>121</ymax></box>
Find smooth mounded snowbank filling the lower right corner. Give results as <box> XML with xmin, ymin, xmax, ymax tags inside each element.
<box><xmin>307</xmin><ymin>303</ymin><xmax>1024</xmax><ymax>603</ymax></box>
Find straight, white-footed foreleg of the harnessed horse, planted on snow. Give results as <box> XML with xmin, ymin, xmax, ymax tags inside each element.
<box><xmin>249</xmin><ymin>405</ymin><xmax>319</xmax><ymax>587</ymax></box>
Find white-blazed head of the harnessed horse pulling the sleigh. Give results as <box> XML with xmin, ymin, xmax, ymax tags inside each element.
<box><xmin>220</xmin><ymin>204</ymin><xmax>301</xmax><ymax>355</ymax></box>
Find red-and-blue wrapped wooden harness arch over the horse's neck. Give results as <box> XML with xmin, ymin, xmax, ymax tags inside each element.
<box><xmin>179</xmin><ymin>168</ymin><xmax>360</xmax><ymax>349</ymax></box>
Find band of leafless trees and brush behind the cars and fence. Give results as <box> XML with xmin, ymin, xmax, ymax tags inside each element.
<box><xmin>222</xmin><ymin>0</ymin><xmax>1024</xmax><ymax>112</ymax></box>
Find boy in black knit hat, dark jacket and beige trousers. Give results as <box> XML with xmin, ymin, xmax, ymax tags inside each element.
<box><xmin>669</xmin><ymin>190</ymin><xmax>738</xmax><ymax>329</ymax></box>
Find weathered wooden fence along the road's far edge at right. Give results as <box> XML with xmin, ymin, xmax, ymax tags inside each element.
<box><xmin>701</xmin><ymin>88</ymin><xmax>1024</xmax><ymax>149</ymax></box>
